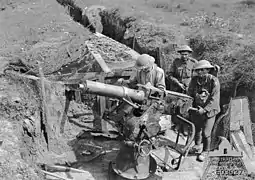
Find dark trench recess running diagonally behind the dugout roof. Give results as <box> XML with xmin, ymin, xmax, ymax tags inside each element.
<box><xmin>57</xmin><ymin>0</ymin><xmax>161</xmax><ymax>66</ymax></box>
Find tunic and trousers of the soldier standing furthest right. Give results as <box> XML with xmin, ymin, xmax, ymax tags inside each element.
<box><xmin>188</xmin><ymin>74</ymin><xmax>220</xmax><ymax>151</ymax></box>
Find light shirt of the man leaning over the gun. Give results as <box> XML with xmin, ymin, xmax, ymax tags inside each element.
<box><xmin>128</xmin><ymin>64</ymin><xmax>166</xmax><ymax>90</ymax></box>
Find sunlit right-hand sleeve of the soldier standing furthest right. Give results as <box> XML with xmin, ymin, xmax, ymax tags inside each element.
<box><xmin>204</xmin><ymin>78</ymin><xmax>220</xmax><ymax>117</ymax></box>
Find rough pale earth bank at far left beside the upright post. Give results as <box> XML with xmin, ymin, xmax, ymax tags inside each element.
<box><xmin>0</xmin><ymin>77</ymin><xmax>41</xmax><ymax>180</ymax></box>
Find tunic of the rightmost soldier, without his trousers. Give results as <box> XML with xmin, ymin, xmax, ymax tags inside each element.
<box><xmin>188</xmin><ymin>74</ymin><xmax>220</xmax><ymax>118</ymax></box>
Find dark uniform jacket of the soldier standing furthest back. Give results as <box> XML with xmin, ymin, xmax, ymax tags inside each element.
<box><xmin>168</xmin><ymin>57</ymin><xmax>197</xmax><ymax>93</ymax></box>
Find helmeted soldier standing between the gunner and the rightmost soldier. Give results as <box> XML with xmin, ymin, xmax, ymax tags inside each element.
<box><xmin>167</xmin><ymin>45</ymin><xmax>197</xmax><ymax>93</ymax></box>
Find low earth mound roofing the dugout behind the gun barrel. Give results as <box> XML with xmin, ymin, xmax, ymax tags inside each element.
<box><xmin>7</xmin><ymin>30</ymin><xmax>138</xmax><ymax>76</ymax></box>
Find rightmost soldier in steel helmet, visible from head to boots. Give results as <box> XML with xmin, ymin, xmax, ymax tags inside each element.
<box><xmin>188</xmin><ymin>60</ymin><xmax>220</xmax><ymax>161</ymax></box>
